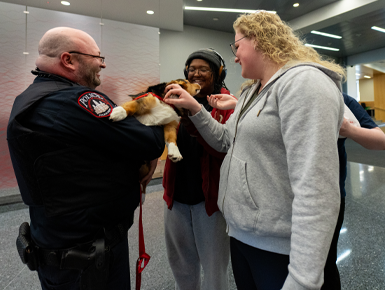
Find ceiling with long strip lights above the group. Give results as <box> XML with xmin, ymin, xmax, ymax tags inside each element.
<box><xmin>4</xmin><ymin>0</ymin><xmax>385</xmax><ymax>78</ymax></box>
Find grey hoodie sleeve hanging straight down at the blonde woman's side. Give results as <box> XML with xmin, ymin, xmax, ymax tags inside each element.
<box><xmin>278</xmin><ymin>69</ymin><xmax>344</xmax><ymax>290</ymax></box>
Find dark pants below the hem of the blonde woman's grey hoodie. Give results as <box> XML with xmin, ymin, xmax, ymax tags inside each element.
<box><xmin>230</xmin><ymin>237</ymin><xmax>289</xmax><ymax>290</ymax></box>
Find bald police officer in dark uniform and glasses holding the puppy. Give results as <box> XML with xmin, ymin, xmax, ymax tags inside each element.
<box><xmin>7</xmin><ymin>27</ymin><xmax>165</xmax><ymax>290</ymax></box>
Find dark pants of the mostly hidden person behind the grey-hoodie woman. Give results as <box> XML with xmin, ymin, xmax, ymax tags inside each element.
<box><xmin>321</xmin><ymin>197</ymin><xmax>345</xmax><ymax>290</ymax></box>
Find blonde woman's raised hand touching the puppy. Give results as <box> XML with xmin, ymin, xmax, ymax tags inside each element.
<box><xmin>163</xmin><ymin>84</ymin><xmax>202</xmax><ymax>115</ymax></box>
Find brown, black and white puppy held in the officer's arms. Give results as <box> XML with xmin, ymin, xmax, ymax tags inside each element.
<box><xmin>110</xmin><ymin>79</ymin><xmax>200</xmax><ymax>191</ymax></box>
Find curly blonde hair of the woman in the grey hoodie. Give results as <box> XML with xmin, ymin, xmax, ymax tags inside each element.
<box><xmin>233</xmin><ymin>11</ymin><xmax>346</xmax><ymax>77</ymax></box>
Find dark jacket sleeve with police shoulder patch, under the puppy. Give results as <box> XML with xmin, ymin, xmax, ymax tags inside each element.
<box><xmin>58</xmin><ymin>92</ymin><xmax>165</xmax><ymax>160</ymax></box>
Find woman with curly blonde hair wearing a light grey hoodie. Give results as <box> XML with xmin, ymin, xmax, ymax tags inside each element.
<box><xmin>165</xmin><ymin>11</ymin><xmax>345</xmax><ymax>290</ymax></box>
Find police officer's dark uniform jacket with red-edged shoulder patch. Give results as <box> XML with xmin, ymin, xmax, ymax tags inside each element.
<box><xmin>7</xmin><ymin>72</ymin><xmax>164</xmax><ymax>248</ymax></box>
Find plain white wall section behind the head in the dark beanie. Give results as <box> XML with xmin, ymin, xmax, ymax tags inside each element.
<box><xmin>159</xmin><ymin>25</ymin><xmax>245</xmax><ymax>95</ymax></box>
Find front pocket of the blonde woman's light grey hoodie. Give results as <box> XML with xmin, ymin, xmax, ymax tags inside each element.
<box><xmin>221</xmin><ymin>155</ymin><xmax>259</xmax><ymax>232</ymax></box>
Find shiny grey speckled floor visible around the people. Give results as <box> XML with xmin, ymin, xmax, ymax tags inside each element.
<box><xmin>0</xmin><ymin>162</ymin><xmax>385</xmax><ymax>290</ymax></box>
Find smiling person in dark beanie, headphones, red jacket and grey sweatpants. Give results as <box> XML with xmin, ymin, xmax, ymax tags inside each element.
<box><xmin>163</xmin><ymin>48</ymin><xmax>233</xmax><ymax>290</ymax></box>
